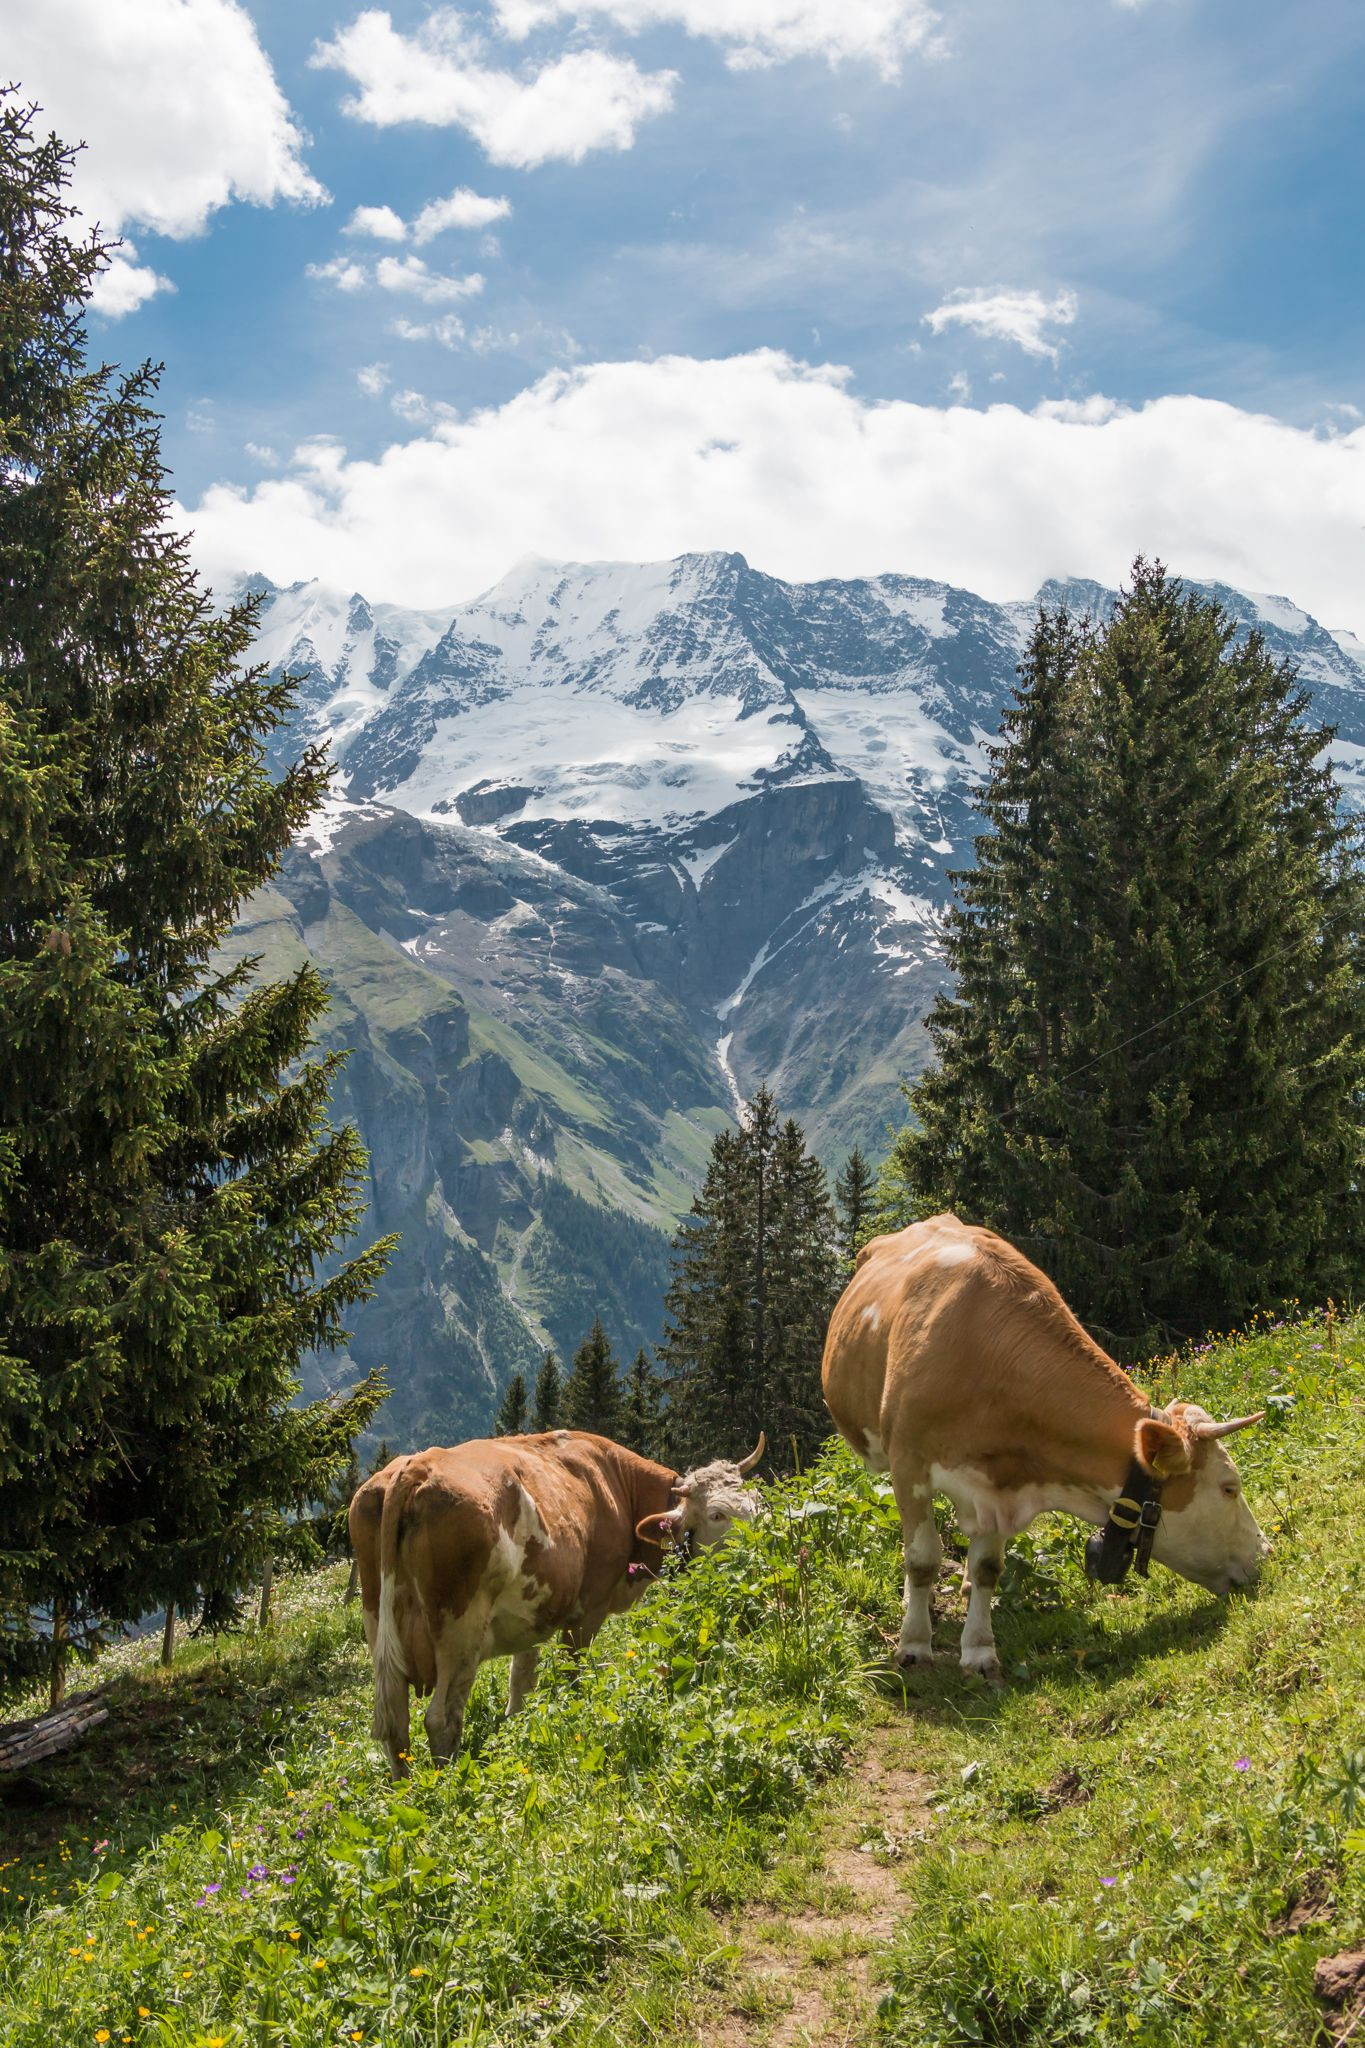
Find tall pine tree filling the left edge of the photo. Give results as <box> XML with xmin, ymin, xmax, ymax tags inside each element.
<box><xmin>0</xmin><ymin>98</ymin><xmax>387</xmax><ymax>1677</ymax></box>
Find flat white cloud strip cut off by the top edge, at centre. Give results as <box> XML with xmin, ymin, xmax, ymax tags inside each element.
<box><xmin>495</xmin><ymin>0</ymin><xmax>939</xmax><ymax>78</ymax></box>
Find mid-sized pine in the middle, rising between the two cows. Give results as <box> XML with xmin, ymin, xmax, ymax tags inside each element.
<box><xmin>659</xmin><ymin>1087</ymin><xmax>837</xmax><ymax>1466</ymax></box>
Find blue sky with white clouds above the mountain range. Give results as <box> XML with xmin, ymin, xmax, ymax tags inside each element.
<box><xmin>0</xmin><ymin>0</ymin><xmax>1365</xmax><ymax>633</ymax></box>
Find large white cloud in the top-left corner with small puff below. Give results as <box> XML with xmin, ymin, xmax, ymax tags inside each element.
<box><xmin>0</xmin><ymin>0</ymin><xmax>327</xmax><ymax>317</ymax></box>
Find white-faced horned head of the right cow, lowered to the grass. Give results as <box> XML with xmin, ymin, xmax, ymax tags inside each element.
<box><xmin>1134</xmin><ymin>1401</ymin><xmax>1271</xmax><ymax>1593</ymax></box>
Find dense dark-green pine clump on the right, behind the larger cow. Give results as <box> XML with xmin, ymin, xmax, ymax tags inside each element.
<box><xmin>884</xmin><ymin>561</ymin><xmax>1365</xmax><ymax>1356</ymax></box>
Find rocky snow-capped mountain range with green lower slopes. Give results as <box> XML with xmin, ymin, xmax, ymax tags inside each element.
<box><xmin>235</xmin><ymin>555</ymin><xmax>1365</xmax><ymax>1419</ymax></box>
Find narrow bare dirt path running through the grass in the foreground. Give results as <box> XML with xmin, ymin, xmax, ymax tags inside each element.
<box><xmin>696</xmin><ymin>1726</ymin><xmax>931</xmax><ymax>2048</ymax></box>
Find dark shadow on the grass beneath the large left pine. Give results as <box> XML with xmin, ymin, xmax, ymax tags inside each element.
<box><xmin>0</xmin><ymin>1610</ymin><xmax>368</xmax><ymax>1892</ymax></box>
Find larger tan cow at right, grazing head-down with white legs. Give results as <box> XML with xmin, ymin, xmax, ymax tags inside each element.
<box><xmin>825</xmin><ymin>1217</ymin><xmax>1269</xmax><ymax>1677</ymax></box>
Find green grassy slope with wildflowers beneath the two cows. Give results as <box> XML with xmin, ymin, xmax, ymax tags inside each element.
<box><xmin>0</xmin><ymin>1323</ymin><xmax>1365</xmax><ymax>2048</ymax></box>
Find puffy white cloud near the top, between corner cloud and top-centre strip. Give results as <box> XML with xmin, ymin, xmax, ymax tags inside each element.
<box><xmin>311</xmin><ymin>6</ymin><xmax>677</xmax><ymax>170</ymax></box>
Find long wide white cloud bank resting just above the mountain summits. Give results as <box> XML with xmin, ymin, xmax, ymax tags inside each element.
<box><xmin>182</xmin><ymin>350</ymin><xmax>1365</xmax><ymax>633</ymax></box>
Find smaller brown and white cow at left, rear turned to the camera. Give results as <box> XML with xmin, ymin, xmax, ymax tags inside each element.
<box><xmin>350</xmin><ymin>1430</ymin><xmax>763</xmax><ymax>1778</ymax></box>
